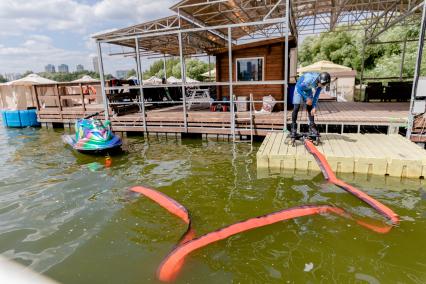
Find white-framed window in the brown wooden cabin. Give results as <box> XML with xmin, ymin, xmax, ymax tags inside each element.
<box><xmin>237</xmin><ymin>57</ymin><xmax>263</xmax><ymax>81</ymax></box>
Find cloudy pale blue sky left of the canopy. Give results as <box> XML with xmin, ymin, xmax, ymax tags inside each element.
<box><xmin>0</xmin><ymin>0</ymin><xmax>178</xmax><ymax>74</ymax></box>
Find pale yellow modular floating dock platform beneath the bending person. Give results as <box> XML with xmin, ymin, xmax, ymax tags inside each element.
<box><xmin>257</xmin><ymin>132</ymin><xmax>426</xmax><ymax>178</ymax></box>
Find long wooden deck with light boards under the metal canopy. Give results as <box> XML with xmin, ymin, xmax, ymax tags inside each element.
<box><xmin>38</xmin><ymin>102</ymin><xmax>409</xmax><ymax>136</ymax></box>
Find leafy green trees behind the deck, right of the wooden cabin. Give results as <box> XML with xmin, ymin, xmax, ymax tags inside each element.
<box><xmin>298</xmin><ymin>23</ymin><xmax>426</xmax><ymax>77</ymax></box>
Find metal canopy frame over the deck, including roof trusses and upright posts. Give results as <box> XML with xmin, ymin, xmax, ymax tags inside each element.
<box><xmin>94</xmin><ymin>0</ymin><xmax>424</xmax><ymax>140</ymax></box>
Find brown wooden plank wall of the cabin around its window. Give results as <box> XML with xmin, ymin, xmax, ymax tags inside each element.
<box><xmin>216</xmin><ymin>38</ymin><xmax>295</xmax><ymax>110</ymax></box>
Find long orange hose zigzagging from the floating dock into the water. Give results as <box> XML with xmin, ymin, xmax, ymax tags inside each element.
<box><xmin>130</xmin><ymin>139</ymin><xmax>399</xmax><ymax>281</ymax></box>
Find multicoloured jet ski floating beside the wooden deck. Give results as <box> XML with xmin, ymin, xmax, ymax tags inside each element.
<box><xmin>62</xmin><ymin>114</ymin><xmax>122</xmax><ymax>153</ymax></box>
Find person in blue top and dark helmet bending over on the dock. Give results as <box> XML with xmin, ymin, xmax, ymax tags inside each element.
<box><xmin>290</xmin><ymin>72</ymin><xmax>331</xmax><ymax>138</ymax></box>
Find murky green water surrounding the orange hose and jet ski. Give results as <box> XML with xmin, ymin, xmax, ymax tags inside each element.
<box><xmin>0</xmin><ymin>125</ymin><xmax>426</xmax><ymax>283</ymax></box>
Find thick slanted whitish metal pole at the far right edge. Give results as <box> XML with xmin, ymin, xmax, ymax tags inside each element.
<box><xmin>406</xmin><ymin>1</ymin><xmax>426</xmax><ymax>139</ymax></box>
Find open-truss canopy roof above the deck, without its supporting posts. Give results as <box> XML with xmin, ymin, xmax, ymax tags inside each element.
<box><xmin>94</xmin><ymin>0</ymin><xmax>423</xmax><ymax>55</ymax></box>
